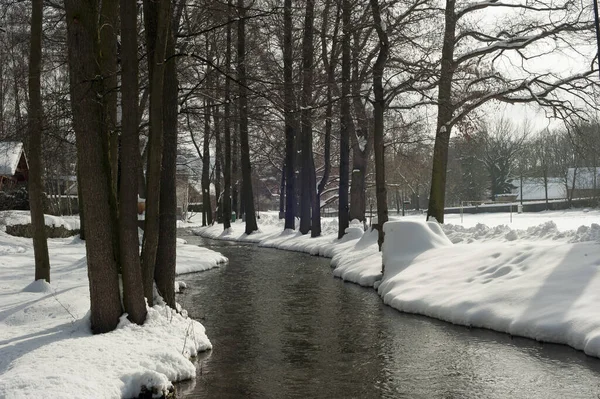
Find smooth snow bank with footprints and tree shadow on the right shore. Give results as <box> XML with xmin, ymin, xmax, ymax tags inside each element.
<box><xmin>378</xmin><ymin>222</ymin><xmax>600</xmax><ymax>356</ymax></box>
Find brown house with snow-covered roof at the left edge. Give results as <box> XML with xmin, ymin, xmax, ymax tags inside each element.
<box><xmin>0</xmin><ymin>141</ymin><xmax>29</xmax><ymax>190</ymax></box>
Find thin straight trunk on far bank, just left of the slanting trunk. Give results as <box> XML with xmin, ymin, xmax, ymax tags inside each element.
<box><xmin>223</xmin><ymin>0</ymin><xmax>232</xmax><ymax>230</ymax></box>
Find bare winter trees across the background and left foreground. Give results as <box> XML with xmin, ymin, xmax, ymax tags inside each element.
<box><xmin>0</xmin><ymin>0</ymin><xmax>599</xmax><ymax>332</ymax></box>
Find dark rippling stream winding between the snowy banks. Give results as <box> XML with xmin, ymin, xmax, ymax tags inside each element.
<box><xmin>177</xmin><ymin>235</ymin><xmax>600</xmax><ymax>399</ymax></box>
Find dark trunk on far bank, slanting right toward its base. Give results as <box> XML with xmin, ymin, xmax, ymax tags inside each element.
<box><xmin>237</xmin><ymin>0</ymin><xmax>258</xmax><ymax>234</ymax></box>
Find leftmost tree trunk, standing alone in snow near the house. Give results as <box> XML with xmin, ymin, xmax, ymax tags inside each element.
<box><xmin>28</xmin><ymin>0</ymin><xmax>50</xmax><ymax>282</ymax></box>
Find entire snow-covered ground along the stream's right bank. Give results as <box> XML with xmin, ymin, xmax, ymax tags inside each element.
<box><xmin>194</xmin><ymin>209</ymin><xmax>600</xmax><ymax>357</ymax></box>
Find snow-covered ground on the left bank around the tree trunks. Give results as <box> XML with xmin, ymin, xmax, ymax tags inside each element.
<box><xmin>0</xmin><ymin>213</ymin><xmax>227</xmax><ymax>398</ymax></box>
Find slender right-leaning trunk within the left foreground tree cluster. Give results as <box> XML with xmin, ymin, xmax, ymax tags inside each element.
<box><xmin>142</xmin><ymin>0</ymin><xmax>171</xmax><ymax>306</ymax></box>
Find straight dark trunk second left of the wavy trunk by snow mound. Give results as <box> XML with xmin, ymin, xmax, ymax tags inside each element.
<box><xmin>338</xmin><ymin>0</ymin><xmax>352</xmax><ymax>238</ymax></box>
